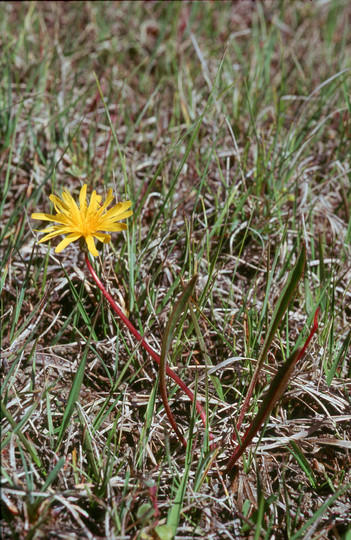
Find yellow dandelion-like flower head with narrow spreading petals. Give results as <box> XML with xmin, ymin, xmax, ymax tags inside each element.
<box><xmin>32</xmin><ymin>184</ymin><xmax>133</xmax><ymax>257</ymax></box>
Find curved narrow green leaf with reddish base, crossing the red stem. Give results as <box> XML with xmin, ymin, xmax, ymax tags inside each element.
<box><xmin>160</xmin><ymin>275</ymin><xmax>197</xmax><ymax>447</ymax></box>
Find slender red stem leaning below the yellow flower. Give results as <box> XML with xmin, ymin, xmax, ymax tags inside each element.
<box><xmin>85</xmin><ymin>253</ymin><xmax>214</xmax><ymax>448</ymax></box>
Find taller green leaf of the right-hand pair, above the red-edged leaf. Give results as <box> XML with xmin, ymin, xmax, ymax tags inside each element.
<box><xmin>237</xmin><ymin>244</ymin><xmax>306</xmax><ymax>429</ymax></box>
